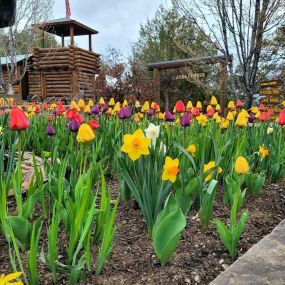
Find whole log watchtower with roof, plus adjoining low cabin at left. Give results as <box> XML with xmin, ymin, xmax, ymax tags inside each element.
<box><xmin>1</xmin><ymin>18</ymin><xmax>100</xmax><ymax>101</ymax></box>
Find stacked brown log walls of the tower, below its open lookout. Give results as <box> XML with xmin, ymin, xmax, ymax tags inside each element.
<box><xmin>29</xmin><ymin>46</ymin><xmax>100</xmax><ymax>98</ymax></box>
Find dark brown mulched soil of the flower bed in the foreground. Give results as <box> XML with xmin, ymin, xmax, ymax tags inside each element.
<box><xmin>0</xmin><ymin>181</ymin><xmax>285</xmax><ymax>285</ymax></box>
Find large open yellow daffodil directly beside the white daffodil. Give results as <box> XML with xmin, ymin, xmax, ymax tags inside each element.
<box><xmin>121</xmin><ymin>129</ymin><xmax>151</xmax><ymax>161</ymax></box>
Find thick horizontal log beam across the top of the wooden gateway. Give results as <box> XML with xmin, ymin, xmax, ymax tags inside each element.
<box><xmin>147</xmin><ymin>55</ymin><xmax>232</xmax><ymax>71</ymax></box>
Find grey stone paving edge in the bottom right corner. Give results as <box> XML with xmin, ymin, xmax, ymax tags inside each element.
<box><xmin>210</xmin><ymin>220</ymin><xmax>285</xmax><ymax>285</ymax></box>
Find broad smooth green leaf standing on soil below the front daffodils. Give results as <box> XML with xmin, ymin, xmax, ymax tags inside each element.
<box><xmin>152</xmin><ymin>196</ymin><xmax>186</xmax><ymax>266</ymax></box>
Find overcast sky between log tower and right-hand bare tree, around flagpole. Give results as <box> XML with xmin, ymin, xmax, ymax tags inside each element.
<box><xmin>54</xmin><ymin>0</ymin><xmax>169</xmax><ymax>56</ymax></box>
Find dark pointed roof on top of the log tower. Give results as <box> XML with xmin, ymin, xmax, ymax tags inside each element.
<box><xmin>33</xmin><ymin>18</ymin><xmax>98</xmax><ymax>37</ymax></box>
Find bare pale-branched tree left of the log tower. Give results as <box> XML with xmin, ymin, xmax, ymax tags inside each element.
<box><xmin>0</xmin><ymin>0</ymin><xmax>53</xmax><ymax>95</ymax></box>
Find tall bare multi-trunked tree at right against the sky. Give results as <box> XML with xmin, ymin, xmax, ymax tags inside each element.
<box><xmin>173</xmin><ymin>0</ymin><xmax>285</xmax><ymax>107</ymax></box>
